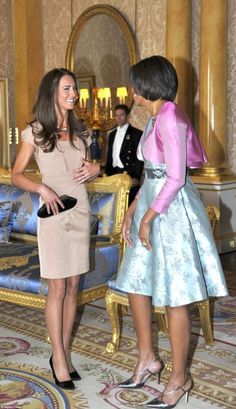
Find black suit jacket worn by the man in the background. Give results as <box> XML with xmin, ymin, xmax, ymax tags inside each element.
<box><xmin>105</xmin><ymin>125</ymin><xmax>143</xmax><ymax>180</ymax></box>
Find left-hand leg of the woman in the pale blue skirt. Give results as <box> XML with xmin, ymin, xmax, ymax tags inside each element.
<box><xmin>128</xmin><ymin>293</ymin><xmax>161</xmax><ymax>383</ymax></box>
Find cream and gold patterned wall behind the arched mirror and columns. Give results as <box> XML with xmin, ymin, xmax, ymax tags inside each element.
<box><xmin>0</xmin><ymin>0</ymin><xmax>236</xmax><ymax>173</ymax></box>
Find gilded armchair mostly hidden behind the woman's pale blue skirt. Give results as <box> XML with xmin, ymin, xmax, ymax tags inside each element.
<box><xmin>105</xmin><ymin>205</ymin><xmax>220</xmax><ymax>353</ymax></box>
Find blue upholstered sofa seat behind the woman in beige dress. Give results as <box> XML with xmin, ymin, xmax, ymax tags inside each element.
<box><xmin>0</xmin><ymin>243</ymin><xmax>119</xmax><ymax>295</ymax></box>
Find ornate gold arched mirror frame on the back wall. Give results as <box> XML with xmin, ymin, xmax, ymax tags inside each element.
<box><xmin>66</xmin><ymin>5</ymin><xmax>138</xmax><ymax>130</ymax></box>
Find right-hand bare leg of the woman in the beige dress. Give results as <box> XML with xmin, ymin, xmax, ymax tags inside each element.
<box><xmin>63</xmin><ymin>275</ymin><xmax>80</xmax><ymax>372</ymax></box>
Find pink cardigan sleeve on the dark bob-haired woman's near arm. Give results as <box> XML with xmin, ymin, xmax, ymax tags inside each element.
<box><xmin>151</xmin><ymin>108</ymin><xmax>187</xmax><ymax>213</ymax></box>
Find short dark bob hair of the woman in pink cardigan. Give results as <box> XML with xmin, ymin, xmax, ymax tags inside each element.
<box><xmin>129</xmin><ymin>55</ymin><xmax>178</xmax><ymax>101</ymax></box>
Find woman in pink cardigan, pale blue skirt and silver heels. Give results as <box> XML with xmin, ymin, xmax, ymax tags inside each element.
<box><xmin>116</xmin><ymin>56</ymin><xmax>227</xmax><ymax>409</ymax></box>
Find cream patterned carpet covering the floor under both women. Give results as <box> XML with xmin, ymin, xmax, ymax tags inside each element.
<box><xmin>0</xmin><ymin>296</ymin><xmax>236</xmax><ymax>409</ymax></box>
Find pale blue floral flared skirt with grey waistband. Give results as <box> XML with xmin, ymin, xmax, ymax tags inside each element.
<box><xmin>116</xmin><ymin>161</ymin><xmax>228</xmax><ymax>307</ymax></box>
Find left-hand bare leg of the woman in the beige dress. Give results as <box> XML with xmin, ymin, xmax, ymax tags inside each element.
<box><xmin>45</xmin><ymin>279</ymin><xmax>70</xmax><ymax>381</ymax></box>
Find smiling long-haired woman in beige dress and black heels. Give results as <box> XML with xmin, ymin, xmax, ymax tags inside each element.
<box><xmin>12</xmin><ymin>68</ymin><xmax>100</xmax><ymax>389</ymax></box>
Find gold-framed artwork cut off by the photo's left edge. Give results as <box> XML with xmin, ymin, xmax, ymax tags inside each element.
<box><xmin>0</xmin><ymin>78</ymin><xmax>11</xmax><ymax>168</ymax></box>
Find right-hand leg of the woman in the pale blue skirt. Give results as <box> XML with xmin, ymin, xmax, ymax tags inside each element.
<box><xmin>163</xmin><ymin>306</ymin><xmax>192</xmax><ymax>403</ymax></box>
